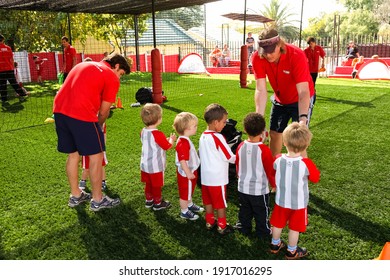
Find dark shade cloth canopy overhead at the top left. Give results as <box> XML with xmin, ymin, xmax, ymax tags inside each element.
<box><xmin>0</xmin><ymin>0</ymin><xmax>220</xmax><ymax>15</ymax></box>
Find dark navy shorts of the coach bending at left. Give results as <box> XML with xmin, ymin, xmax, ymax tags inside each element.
<box><xmin>54</xmin><ymin>113</ymin><xmax>106</xmax><ymax>156</ymax></box>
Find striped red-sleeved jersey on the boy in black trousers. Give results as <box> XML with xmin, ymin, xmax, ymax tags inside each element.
<box><xmin>236</xmin><ymin>140</ymin><xmax>275</xmax><ymax>195</ymax></box>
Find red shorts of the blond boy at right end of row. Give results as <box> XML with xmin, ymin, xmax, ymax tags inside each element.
<box><xmin>270</xmin><ymin>204</ymin><xmax>308</xmax><ymax>232</ymax></box>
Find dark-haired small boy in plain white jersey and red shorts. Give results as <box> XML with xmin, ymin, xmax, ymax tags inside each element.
<box><xmin>199</xmin><ymin>104</ymin><xmax>236</xmax><ymax>235</ymax></box>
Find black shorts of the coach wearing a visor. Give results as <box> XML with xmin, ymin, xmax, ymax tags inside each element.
<box><xmin>270</xmin><ymin>96</ymin><xmax>314</xmax><ymax>133</ymax></box>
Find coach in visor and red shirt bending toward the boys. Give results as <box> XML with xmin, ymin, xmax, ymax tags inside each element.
<box><xmin>252</xmin><ymin>29</ymin><xmax>314</xmax><ymax>156</ymax></box>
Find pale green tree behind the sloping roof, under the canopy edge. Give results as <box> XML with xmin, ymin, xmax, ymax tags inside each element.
<box><xmin>156</xmin><ymin>6</ymin><xmax>204</xmax><ymax>30</ymax></box>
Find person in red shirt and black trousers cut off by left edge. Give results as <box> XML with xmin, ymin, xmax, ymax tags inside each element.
<box><xmin>0</xmin><ymin>34</ymin><xmax>26</xmax><ymax>101</ymax></box>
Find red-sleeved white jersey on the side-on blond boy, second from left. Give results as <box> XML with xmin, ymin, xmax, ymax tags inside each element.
<box><xmin>175</xmin><ymin>136</ymin><xmax>200</xmax><ymax>177</ymax></box>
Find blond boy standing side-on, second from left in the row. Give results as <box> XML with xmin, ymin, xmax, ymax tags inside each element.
<box><xmin>173</xmin><ymin>112</ymin><xmax>204</xmax><ymax>221</ymax></box>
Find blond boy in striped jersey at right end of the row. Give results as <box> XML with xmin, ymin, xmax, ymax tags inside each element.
<box><xmin>270</xmin><ymin>122</ymin><xmax>320</xmax><ymax>259</ymax></box>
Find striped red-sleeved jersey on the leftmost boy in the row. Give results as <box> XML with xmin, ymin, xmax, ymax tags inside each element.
<box><xmin>141</xmin><ymin>128</ymin><xmax>172</xmax><ymax>173</ymax></box>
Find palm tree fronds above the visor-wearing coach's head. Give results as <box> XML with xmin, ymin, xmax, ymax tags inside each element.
<box><xmin>260</xmin><ymin>0</ymin><xmax>299</xmax><ymax>39</ymax></box>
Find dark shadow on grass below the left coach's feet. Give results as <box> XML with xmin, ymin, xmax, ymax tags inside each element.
<box><xmin>74</xmin><ymin>203</ymin><xmax>174</xmax><ymax>260</ymax></box>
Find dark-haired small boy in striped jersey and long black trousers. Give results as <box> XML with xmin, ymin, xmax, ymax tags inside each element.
<box><xmin>235</xmin><ymin>113</ymin><xmax>275</xmax><ymax>238</ymax></box>
